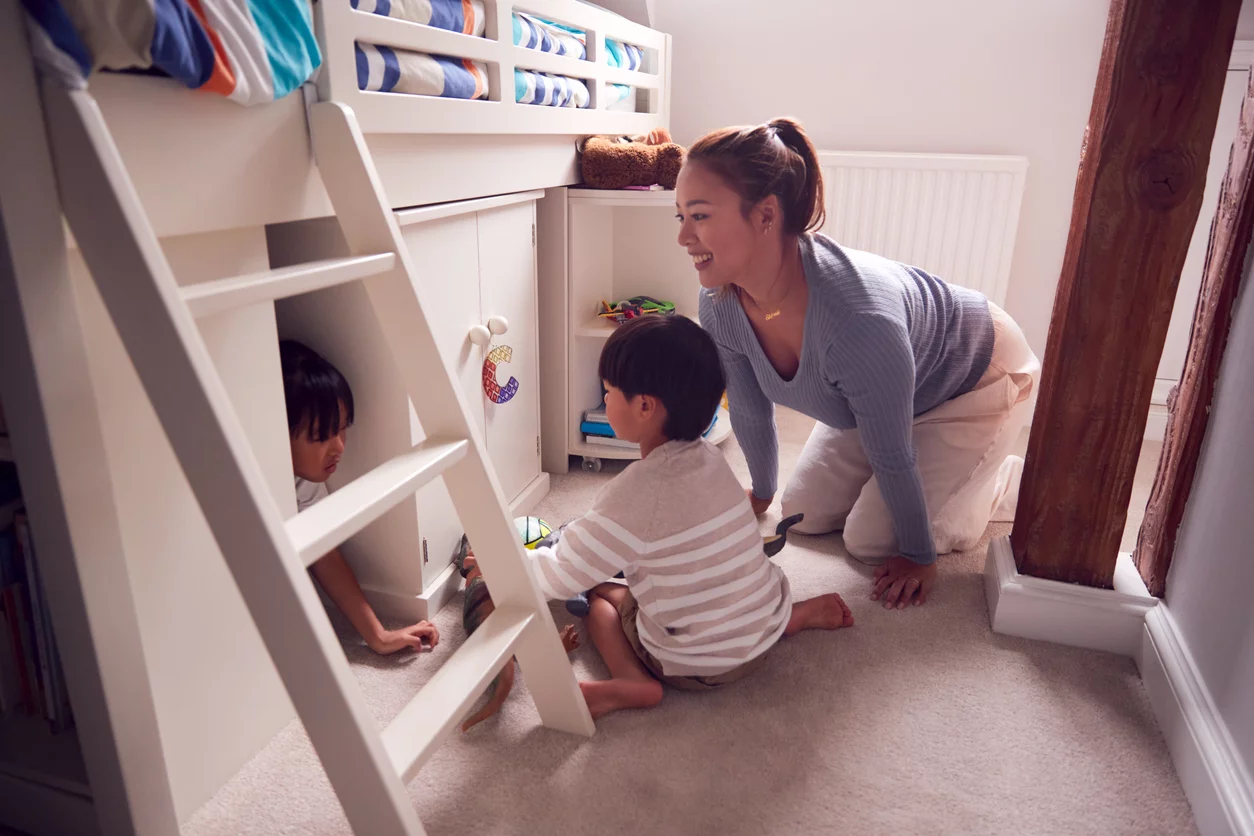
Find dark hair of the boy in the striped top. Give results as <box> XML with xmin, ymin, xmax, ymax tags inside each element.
<box><xmin>597</xmin><ymin>315</ymin><xmax>726</xmax><ymax>441</ymax></box>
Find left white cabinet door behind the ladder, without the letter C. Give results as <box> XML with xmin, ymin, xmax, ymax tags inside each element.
<box><xmin>401</xmin><ymin>214</ymin><xmax>484</xmax><ymax>589</ymax></box>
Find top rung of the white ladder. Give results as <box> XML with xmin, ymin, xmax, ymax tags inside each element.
<box><xmin>183</xmin><ymin>252</ymin><xmax>396</xmax><ymax>317</ymax></box>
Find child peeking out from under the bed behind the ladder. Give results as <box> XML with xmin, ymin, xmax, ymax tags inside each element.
<box><xmin>278</xmin><ymin>340</ymin><xmax>440</xmax><ymax>654</ymax></box>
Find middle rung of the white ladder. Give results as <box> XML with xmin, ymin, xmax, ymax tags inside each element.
<box><xmin>287</xmin><ymin>439</ymin><xmax>470</xmax><ymax>567</ymax></box>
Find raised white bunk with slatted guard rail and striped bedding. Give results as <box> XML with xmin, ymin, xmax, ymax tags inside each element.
<box><xmin>19</xmin><ymin>0</ymin><xmax>671</xmax><ymax>237</ymax></box>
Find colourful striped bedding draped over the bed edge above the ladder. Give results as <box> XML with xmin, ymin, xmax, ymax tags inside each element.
<box><xmin>21</xmin><ymin>0</ymin><xmax>322</xmax><ymax>105</ymax></box>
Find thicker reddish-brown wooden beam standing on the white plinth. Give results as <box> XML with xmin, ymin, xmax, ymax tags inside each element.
<box><xmin>1011</xmin><ymin>0</ymin><xmax>1240</xmax><ymax>588</ymax></box>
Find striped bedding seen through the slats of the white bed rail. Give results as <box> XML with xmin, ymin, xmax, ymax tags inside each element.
<box><xmin>350</xmin><ymin>0</ymin><xmax>643</xmax><ymax>108</ymax></box>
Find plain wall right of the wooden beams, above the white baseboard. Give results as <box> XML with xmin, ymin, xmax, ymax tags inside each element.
<box><xmin>1166</xmin><ymin>248</ymin><xmax>1254</xmax><ymax>766</ymax></box>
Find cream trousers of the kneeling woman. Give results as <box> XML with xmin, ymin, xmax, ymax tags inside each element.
<box><xmin>781</xmin><ymin>302</ymin><xmax>1041</xmax><ymax>563</ymax></box>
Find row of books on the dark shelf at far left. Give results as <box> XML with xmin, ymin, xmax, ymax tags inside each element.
<box><xmin>0</xmin><ymin>462</ymin><xmax>74</xmax><ymax>732</ymax></box>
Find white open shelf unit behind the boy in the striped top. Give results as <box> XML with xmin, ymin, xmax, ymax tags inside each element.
<box><xmin>539</xmin><ymin>188</ymin><xmax>731</xmax><ymax>473</ymax></box>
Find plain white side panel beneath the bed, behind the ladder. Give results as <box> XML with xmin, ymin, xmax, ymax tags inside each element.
<box><xmin>70</xmin><ymin>228</ymin><xmax>296</xmax><ymax>821</ymax></box>
